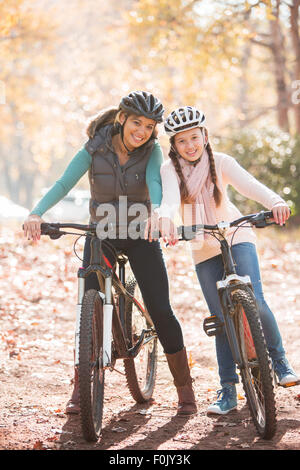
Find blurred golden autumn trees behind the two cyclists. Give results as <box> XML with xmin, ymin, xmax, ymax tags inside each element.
<box><xmin>0</xmin><ymin>0</ymin><xmax>300</xmax><ymax>220</ymax></box>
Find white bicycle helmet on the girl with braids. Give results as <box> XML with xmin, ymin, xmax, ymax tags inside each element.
<box><xmin>164</xmin><ymin>106</ymin><xmax>205</xmax><ymax>137</ymax></box>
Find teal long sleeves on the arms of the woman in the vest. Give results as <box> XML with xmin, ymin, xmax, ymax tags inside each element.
<box><xmin>30</xmin><ymin>142</ymin><xmax>163</xmax><ymax>217</ymax></box>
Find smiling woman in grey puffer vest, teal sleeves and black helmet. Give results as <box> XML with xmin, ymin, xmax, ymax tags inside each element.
<box><xmin>24</xmin><ymin>91</ymin><xmax>197</xmax><ymax>415</ymax></box>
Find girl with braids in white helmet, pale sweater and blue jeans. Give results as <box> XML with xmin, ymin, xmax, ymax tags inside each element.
<box><xmin>156</xmin><ymin>106</ymin><xmax>298</xmax><ymax>414</ymax></box>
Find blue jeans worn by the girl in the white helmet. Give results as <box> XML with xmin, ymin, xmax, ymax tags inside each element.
<box><xmin>195</xmin><ymin>242</ymin><xmax>285</xmax><ymax>386</ymax></box>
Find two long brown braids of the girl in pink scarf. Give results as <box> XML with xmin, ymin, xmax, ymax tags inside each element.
<box><xmin>169</xmin><ymin>129</ymin><xmax>222</xmax><ymax>207</ymax></box>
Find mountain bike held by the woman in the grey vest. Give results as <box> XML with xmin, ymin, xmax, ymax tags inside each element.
<box><xmin>41</xmin><ymin>223</ymin><xmax>158</xmax><ymax>441</ymax></box>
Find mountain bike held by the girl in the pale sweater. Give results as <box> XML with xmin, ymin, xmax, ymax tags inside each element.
<box><xmin>178</xmin><ymin>211</ymin><xmax>288</xmax><ymax>439</ymax></box>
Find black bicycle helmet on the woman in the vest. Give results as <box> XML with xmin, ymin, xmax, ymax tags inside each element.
<box><xmin>120</xmin><ymin>91</ymin><xmax>164</xmax><ymax>122</ymax></box>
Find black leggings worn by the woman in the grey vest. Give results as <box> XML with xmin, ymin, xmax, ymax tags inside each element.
<box><xmin>83</xmin><ymin>237</ymin><xmax>184</xmax><ymax>354</ymax></box>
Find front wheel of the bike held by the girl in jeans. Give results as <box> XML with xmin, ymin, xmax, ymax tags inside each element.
<box><xmin>232</xmin><ymin>290</ymin><xmax>276</xmax><ymax>439</ymax></box>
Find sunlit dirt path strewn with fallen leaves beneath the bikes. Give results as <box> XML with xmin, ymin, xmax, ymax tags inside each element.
<box><xmin>0</xmin><ymin>229</ymin><xmax>300</xmax><ymax>451</ymax></box>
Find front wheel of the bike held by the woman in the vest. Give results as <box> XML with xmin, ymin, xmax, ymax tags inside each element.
<box><xmin>78</xmin><ymin>289</ymin><xmax>104</xmax><ymax>441</ymax></box>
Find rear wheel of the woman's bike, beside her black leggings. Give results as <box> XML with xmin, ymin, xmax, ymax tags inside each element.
<box><xmin>124</xmin><ymin>278</ymin><xmax>157</xmax><ymax>403</ymax></box>
